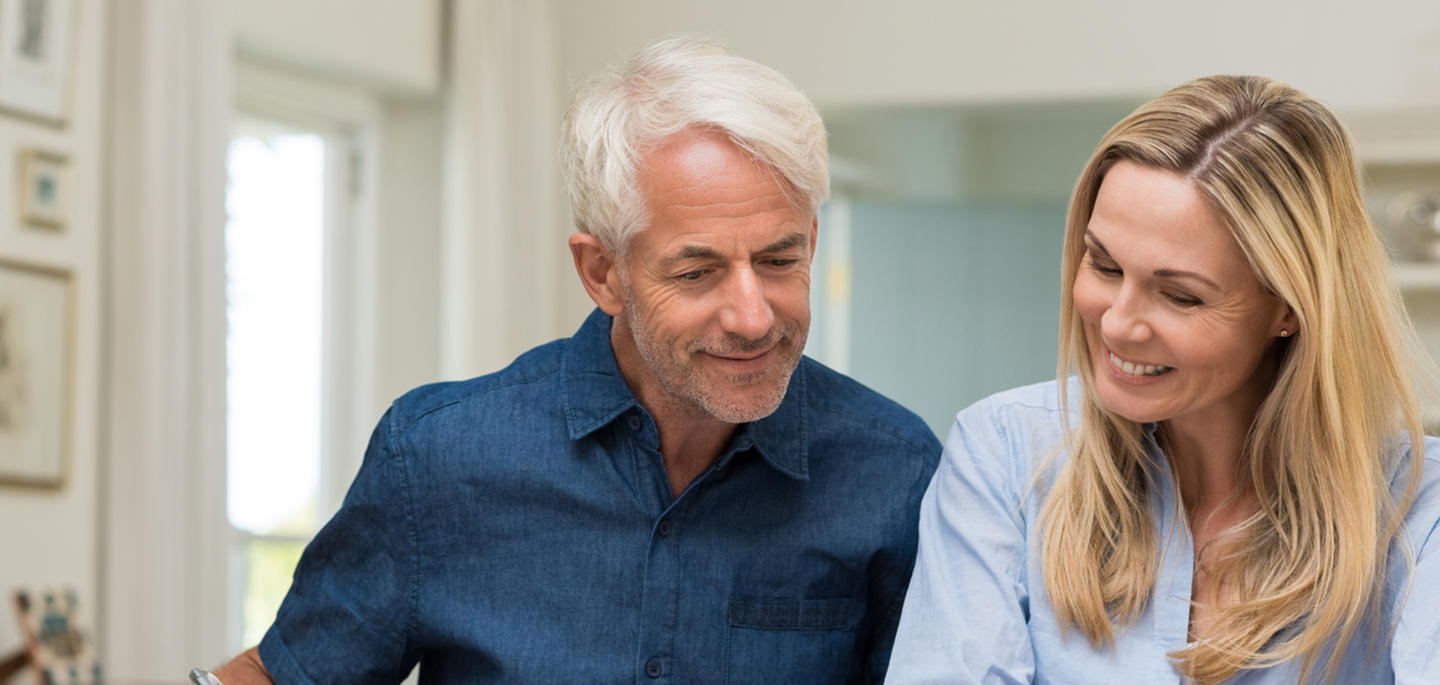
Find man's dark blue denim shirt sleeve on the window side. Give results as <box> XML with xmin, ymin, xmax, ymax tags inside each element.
<box><xmin>259</xmin><ymin>409</ymin><xmax>419</xmax><ymax>685</ymax></box>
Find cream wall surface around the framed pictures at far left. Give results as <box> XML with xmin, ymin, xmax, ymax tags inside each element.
<box><xmin>0</xmin><ymin>0</ymin><xmax>109</xmax><ymax>656</ymax></box>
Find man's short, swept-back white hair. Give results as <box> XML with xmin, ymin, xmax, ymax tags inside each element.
<box><xmin>560</xmin><ymin>36</ymin><xmax>829</xmax><ymax>255</ymax></box>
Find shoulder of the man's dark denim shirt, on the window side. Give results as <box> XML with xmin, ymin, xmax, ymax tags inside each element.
<box><xmin>390</xmin><ymin>338</ymin><xmax>570</xmax><ymax>429</ymax></box>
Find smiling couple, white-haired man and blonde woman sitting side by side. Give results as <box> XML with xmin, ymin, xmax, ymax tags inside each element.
<box><xmin>205</xmin><ymin>37</ymin><xmax>1440</xmax><ymax>685</ymax></box>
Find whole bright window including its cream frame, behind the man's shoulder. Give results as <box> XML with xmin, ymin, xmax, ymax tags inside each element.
<box><xmin>225</xmin><ymin>65</ymin><xmax>380</xmax><ymax>650</ymax></box>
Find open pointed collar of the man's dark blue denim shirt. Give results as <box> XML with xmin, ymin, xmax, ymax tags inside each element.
<box><xmin>560</xmin><ymin>308</ymin><xmax>809</xmax><ymax>481</ymax></box>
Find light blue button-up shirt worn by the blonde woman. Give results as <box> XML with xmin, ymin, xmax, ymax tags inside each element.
<box><xmin>886</xmin><ymin>381</ymin><xmax>1440</xmax><ymax>685</ymax></box>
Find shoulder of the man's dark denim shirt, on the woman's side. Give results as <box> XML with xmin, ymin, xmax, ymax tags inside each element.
<box><xmin>801</xmin><ymin>357</ymin><xmax>940</xmax><ymax>455</ymax></box>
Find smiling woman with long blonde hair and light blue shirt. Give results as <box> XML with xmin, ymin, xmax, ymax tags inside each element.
<box><xmin>887</xmin><ymin>76</ymin><xmax>1440</xmax><ymax>684</ymax></box>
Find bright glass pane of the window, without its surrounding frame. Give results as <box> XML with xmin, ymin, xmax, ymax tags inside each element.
<box><xmin>225</xmin><ymin>115</ymin><xmax>325</xmax><ymax>645</ymax></box>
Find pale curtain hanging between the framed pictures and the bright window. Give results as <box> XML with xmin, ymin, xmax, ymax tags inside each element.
<box><xmin>99</xmin><ymin>0</ymin><xmax>233</xmax><ymax>673</ymax></box>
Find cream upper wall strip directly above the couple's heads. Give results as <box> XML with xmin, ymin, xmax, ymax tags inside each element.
<box><xmin>556</xmin><ymin>0</ymin><xmax>1440</xmax><ymax>109</ymax></box>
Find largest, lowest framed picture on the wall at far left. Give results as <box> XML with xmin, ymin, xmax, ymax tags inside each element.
<box><xmin>0</xmin><ymin>258</ymin><xmax>75</xmax><ymax>488</ymax></box>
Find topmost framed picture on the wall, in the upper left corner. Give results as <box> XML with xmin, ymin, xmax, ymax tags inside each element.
<box><xmin>0</xmin><ymin>0</ymin><xmax>79</xmax><ymax>124</ymax></box>
